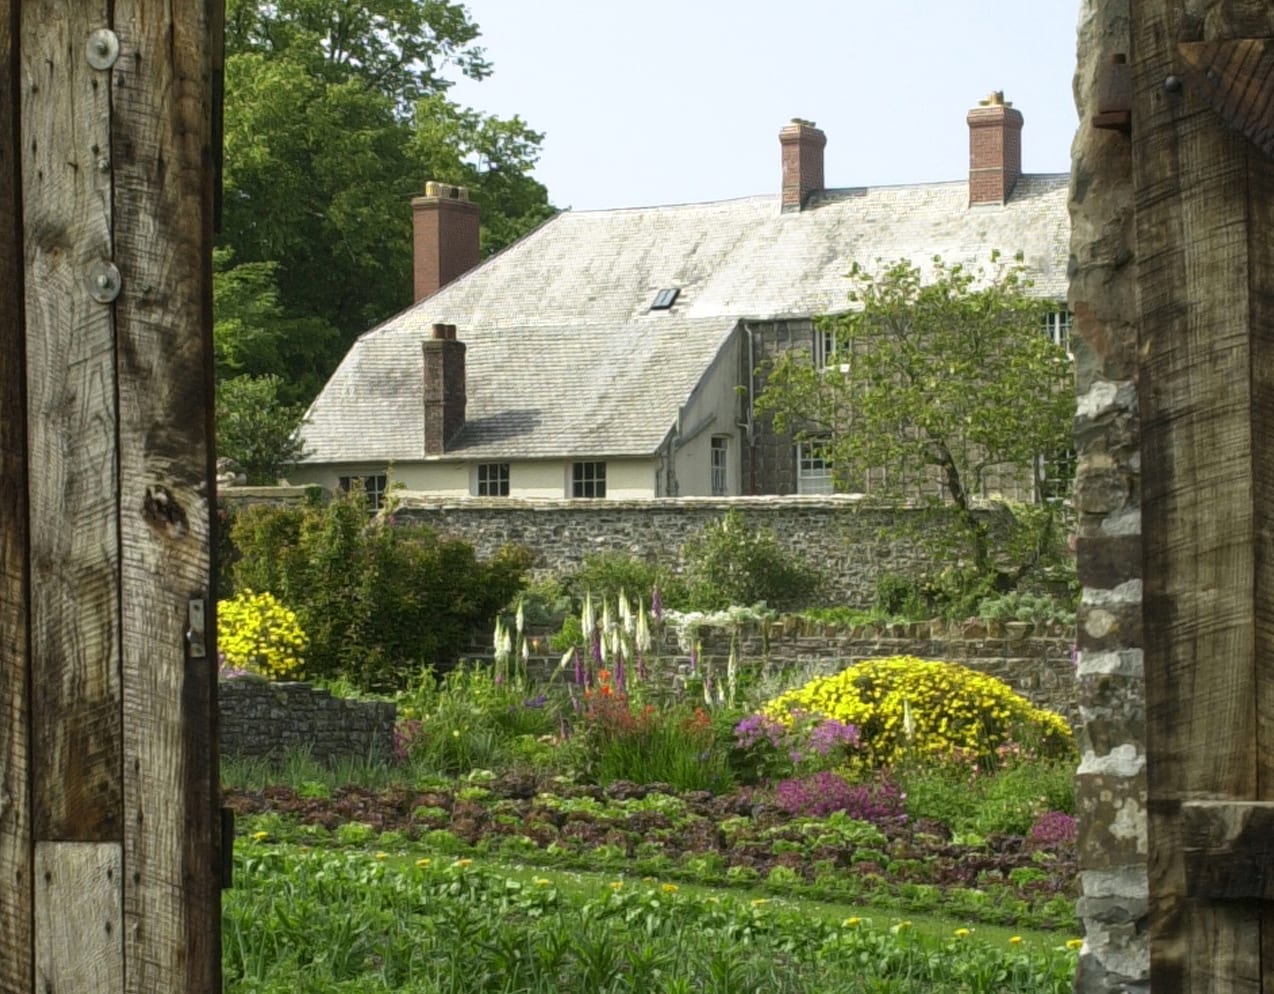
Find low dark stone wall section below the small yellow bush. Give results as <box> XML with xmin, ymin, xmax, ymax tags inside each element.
<box><xmin>218</xmin><ymin>677</ymin><xmax>396</xmax><ymax>763</ymax></box>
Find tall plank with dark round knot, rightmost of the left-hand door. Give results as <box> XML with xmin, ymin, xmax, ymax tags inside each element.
<box><xmin>111</xmin><ymin>0</ymin><xmax>220</xmax><ymax>994</ymax></box>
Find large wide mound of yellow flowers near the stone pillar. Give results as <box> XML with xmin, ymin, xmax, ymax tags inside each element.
<box><xmin>762</xmin><ymin>656</ymin><xmax>1074</xmax><ymax>765</ymax></box>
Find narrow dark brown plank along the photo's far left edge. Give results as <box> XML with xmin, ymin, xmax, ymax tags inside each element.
<box><xmin>0</xmin><ymin>0</ymin><xmax>34</xmax><ymax>994</ymax></box>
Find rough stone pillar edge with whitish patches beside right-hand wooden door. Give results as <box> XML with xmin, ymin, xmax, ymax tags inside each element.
<box><xmin>1070</xmin><ymin>0</ymin><xmax>1150</xmax><ymax>994</ymax></box>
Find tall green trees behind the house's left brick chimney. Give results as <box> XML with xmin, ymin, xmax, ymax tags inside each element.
<box><xmin>214</xmin><ymin>0</ymin><xmax>553</xmax><ymax>403</ymax></box>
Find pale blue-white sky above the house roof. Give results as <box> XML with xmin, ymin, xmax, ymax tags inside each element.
<box><xmin>451</xmin><ymin>0</ymin><xmax>1079</xmax><ymax>210</ymax></box>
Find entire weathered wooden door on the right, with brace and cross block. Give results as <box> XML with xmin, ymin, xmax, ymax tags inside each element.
<box><xmin>1129</xmin><ymin>0</ymin><xmax>1274</xmax><ymax>994</ymax></box>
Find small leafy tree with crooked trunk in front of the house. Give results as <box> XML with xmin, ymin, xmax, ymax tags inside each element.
<box><xmin>757</xmin><ymin>255</ymin><xmax>1075</xmax><ymax>601</ymax></box>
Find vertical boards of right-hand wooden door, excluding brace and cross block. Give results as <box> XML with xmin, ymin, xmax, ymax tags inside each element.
<box><xmin>1131</xmin><ymin>0</ymin><xmax>1274</xmax><ymax>994</ymax></box>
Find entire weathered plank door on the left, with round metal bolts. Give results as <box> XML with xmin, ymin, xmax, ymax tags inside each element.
<box><xmin>0</xmin><ymin>0</ymin><xmax>222</xmax><ymax>994</ymax></box>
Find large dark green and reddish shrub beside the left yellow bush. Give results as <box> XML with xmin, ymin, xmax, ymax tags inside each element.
<box><xmin>226</xmin><ymin>493</ymin><xmax>530</xmax><ymax>691</ymax></box>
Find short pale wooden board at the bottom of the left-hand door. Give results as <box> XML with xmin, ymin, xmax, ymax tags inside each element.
<box><xmin>34</xmin><ymin>842</ymin><xmax>124</xmax><ymax>994</ymax></box>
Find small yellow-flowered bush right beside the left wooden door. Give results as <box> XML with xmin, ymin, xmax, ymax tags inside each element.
<box><xmin>217</xmin><ymin>590</ymin><xmax>310</xmax><ymax>681</ymax></box>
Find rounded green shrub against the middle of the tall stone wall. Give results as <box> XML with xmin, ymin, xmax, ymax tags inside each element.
<box><xmin>682</xmin><ymin>510</ymin><xmax>823</xmax><ymax>610</ymax></box>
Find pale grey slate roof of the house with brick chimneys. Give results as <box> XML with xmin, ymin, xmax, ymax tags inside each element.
<box><xmin>303</xmin><ymin>173</ymin><xmax>1070</xmax><ymax>464</ymax></box>
